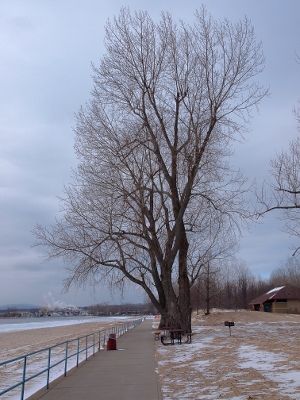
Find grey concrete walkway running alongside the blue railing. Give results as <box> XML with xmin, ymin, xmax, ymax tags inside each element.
<box><xmin>29</xmin><ymin>319</ymin><xmax>162</xmax><ymax>400</ymax></box>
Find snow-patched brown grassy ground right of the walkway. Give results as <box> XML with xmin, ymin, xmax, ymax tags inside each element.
<box><xmin>155</xmin><ymin>311</ymin><xmax>300</xmax><ymax>400</ymax></box>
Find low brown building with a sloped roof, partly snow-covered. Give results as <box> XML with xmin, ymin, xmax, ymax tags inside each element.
<box><xmin>249</xmin><ymin>285</ymin><xmax>300</xmax><ymax>314</ymax></box>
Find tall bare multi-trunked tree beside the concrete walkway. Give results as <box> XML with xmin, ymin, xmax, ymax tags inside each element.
<box><xmin>34</xmin><ymin>8</ymin><xmax>266</xmax><ymax>331</ymax></box>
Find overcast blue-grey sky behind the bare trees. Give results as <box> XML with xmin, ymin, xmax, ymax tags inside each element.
<box><xmin>0</xmin><ymin>0</ymin><xmax>300</xmax><ymax>305</ymax></box>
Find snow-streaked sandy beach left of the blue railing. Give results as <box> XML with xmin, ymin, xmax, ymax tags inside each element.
<box><xmin>0</xmin><ymin>317</ymin><xmax>132</xmax><ymax>400</ymax></box>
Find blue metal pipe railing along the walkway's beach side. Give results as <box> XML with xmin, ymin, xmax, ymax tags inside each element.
<box><xmin>0</xmin><ymin>318</ymin><xmax>144</xmax><ymax>400</ymax></box>
